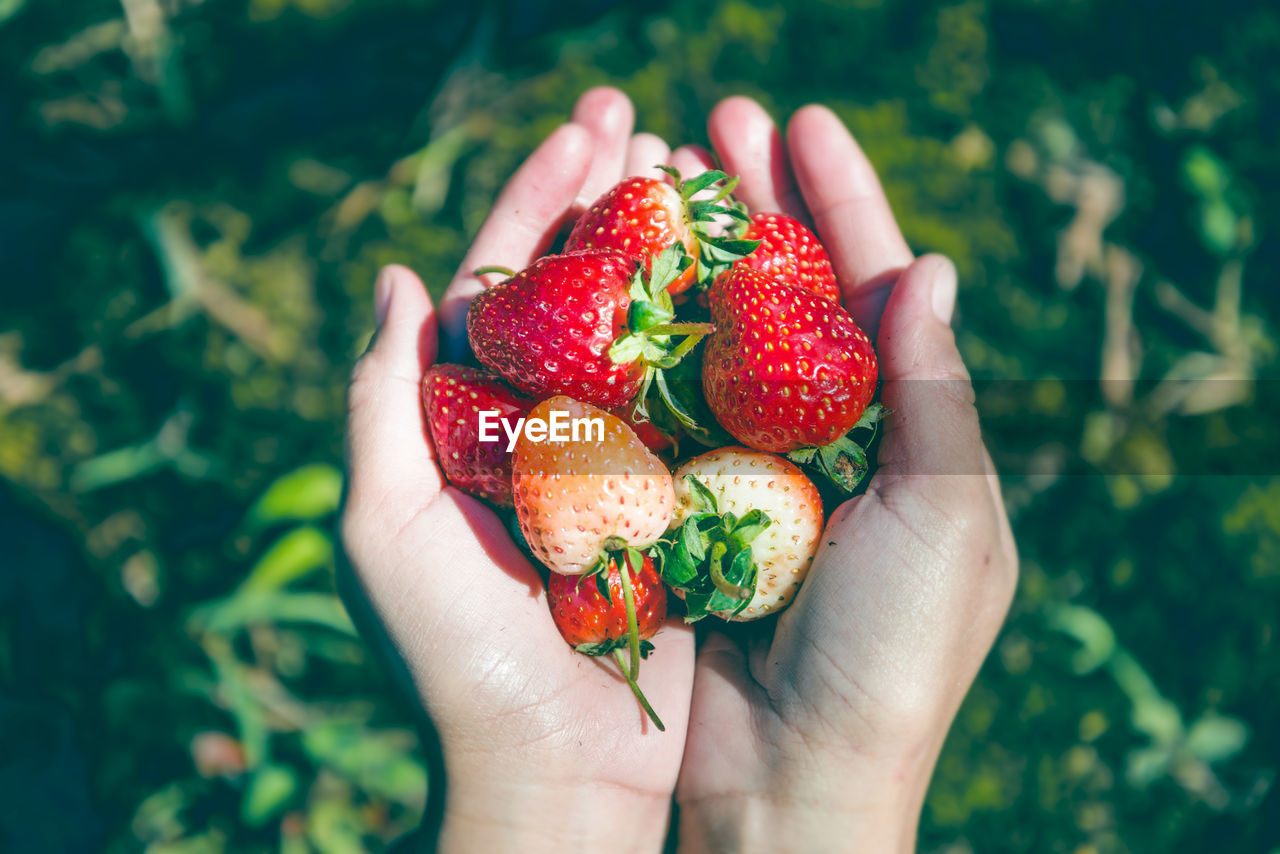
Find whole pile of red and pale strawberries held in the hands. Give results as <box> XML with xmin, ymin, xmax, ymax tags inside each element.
<box><xmin>422</xmin><ymin>170</ymin><xmax>883</xmax><ymax>729</ymax></box>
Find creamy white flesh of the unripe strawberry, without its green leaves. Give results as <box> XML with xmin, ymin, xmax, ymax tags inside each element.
<box><xmin>664</xmin><ymin>447</ymin><xmax>823</xmax><ymax>620</ymax></box>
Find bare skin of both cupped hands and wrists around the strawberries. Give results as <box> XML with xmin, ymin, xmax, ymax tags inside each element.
<box><xmin>339</xmin><ymin>88</ymin><xmax>1016</xmax><ymax>851</ymax></box>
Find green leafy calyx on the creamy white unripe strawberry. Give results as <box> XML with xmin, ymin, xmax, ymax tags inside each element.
<box><xmin>657</xmin><ymin>475</ymin><xmax>773</xmax><ymax>622</ymax></box>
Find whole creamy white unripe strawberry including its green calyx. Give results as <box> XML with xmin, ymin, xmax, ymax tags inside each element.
<box><xmin>662</xmin><ymin>447</ymin><xmax>823</xmax><ymax>621</ymax></box>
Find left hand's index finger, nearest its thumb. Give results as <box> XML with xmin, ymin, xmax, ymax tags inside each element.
<box><xmin>439</xmin><ymin>124</ymin><xmax>593</xmax><ymax>348</ymax></box>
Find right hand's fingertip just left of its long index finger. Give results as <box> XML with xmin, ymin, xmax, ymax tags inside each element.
<box><xmin>707</xmin><ymin>96</ymin><xmax>806</xmax><ymax>219</ymax></box>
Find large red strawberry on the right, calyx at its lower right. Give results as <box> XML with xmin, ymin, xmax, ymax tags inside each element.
<box><xmin>703</xmin><ymin>268</ymin><xmax>881</xmax><ymax>492</ymax></box>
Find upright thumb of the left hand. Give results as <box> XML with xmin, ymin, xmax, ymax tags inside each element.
<box><xmin>346</xmin><ymin>265</ymin><xmax>444</xmax><ymax>524</ymax></box>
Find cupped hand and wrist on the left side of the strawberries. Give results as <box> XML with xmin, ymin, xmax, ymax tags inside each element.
<box><xmin>340</xmin><ymin>90</ymin><xmax>694</xmax><ymax>851</ymax></box>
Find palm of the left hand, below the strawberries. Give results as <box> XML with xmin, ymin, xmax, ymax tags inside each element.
<box><xmin>389</xmin><ymin>488</ymin><xmax>694</xmax><ymax>795</ymax></box>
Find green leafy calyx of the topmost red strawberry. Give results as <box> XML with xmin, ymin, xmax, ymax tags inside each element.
<box><xmin>658</xmin><ymin>166</ymin><xmax>760</xmax><ymax>289</ymax></box>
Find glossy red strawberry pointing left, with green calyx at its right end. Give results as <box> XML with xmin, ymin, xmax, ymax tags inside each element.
<box><xmin>467</xmin><ymin>247</ymin><xmax>710</xmax><ymax>407</ymax></box>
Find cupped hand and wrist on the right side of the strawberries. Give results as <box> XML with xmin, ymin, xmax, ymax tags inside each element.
<box><xmin>677</xmin><ymin>97</ymin><xmax>1018</xmax><ymax>853</ymax></box>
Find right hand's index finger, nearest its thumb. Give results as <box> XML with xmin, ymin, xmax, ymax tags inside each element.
<box><xmin>787</xmin><ymin>100</ymin><xmax>913</xmax><ymax>327</ymax></box>
